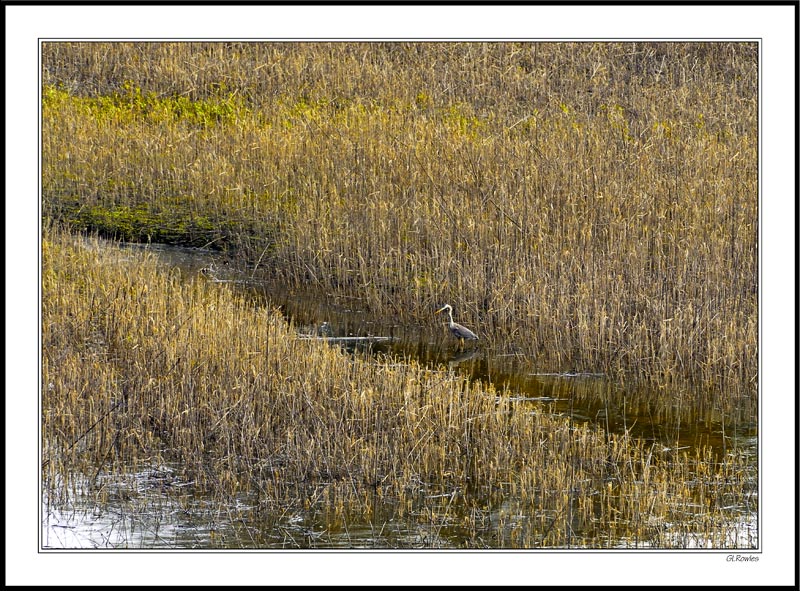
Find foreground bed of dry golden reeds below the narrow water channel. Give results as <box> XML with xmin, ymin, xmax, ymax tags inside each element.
<box><xmin>42</xmin><ymin>227</ymin><xmax>755</xmax><ymax>547</ymax></box>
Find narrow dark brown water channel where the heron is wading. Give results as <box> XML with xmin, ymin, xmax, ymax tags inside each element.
<box><xmin>123</xmin><ymin>239</ymin><xmax>757</xmax><ymax>455</ymax></box>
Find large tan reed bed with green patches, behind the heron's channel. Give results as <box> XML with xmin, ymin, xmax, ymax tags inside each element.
<box><xmin>42</xmin><ymin>43</ymin><xmax>758</xmax><ymax>432</ymax></box>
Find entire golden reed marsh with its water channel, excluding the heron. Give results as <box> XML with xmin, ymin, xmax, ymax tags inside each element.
<box><xmin>41</xmin><ymin>42</ymin><xmax>758</xmax><ymax>549</ymax></box>
